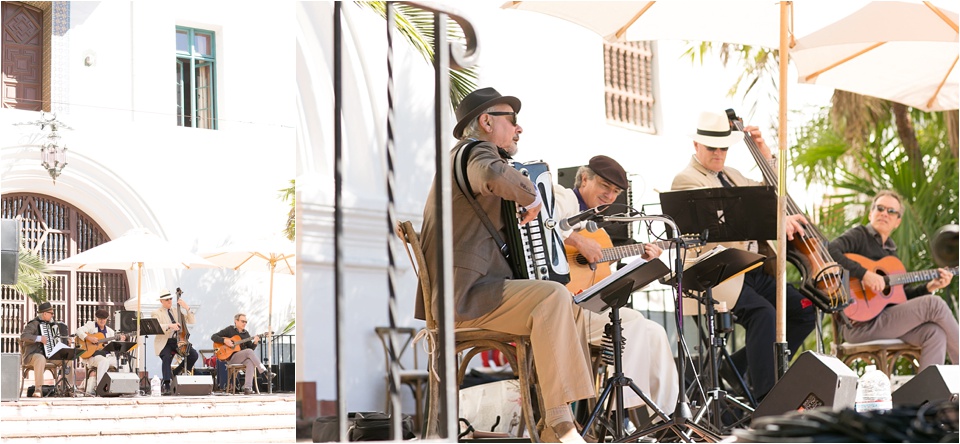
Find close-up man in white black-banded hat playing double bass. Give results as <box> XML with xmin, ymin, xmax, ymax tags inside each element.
<box><xmin>671</xmin><ymin>112</ymin><xmax>816</xmax><ymax>401</ymax></box>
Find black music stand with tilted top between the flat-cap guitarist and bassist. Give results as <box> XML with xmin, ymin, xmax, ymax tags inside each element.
<box><xmin>666</xmin><ymin>246</ymin><xmax>765</xmax><ymax>434</ymax></box>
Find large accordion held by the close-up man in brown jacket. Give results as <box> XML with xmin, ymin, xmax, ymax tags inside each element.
<box><xmin>503</xmin><ymin>162</ymin><xmax>570</xmax><ymax>284</ymax></box>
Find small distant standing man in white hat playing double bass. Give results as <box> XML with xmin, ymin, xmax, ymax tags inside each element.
<box><xmin>151</xmin><ymin>290</ymin><xmax>200</xmax><ymax>395</ymax></box>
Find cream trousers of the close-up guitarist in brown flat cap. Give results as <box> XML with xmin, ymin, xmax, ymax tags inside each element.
<box><xmin>584</xmin><ymin>308</ymin><xmax>680</xmax><ymax>414</ymax></box>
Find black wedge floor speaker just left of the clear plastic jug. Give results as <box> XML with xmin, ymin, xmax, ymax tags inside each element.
<box><xmin>753</xmin><ymin>352</ymin><xmax>857</xmax><ymax>419</ymax></box>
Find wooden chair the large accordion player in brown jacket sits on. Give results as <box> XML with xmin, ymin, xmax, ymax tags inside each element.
<box><xmin>397</xmin><ymin>221</ymin><xmax>543</xmax><ymax>442</ymax></box>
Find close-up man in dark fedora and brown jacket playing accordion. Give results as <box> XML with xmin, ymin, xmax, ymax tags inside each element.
<box><xmin>416</xmin><ymin>88</ymin><xmax>596</xmax><ymax>442</ymax></box>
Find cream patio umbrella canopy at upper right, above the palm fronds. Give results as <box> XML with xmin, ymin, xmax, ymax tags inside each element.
<box><xmin>790</xmin><ymin>2</ymin><xmax>960</xmax><ymax>111</ymax></box>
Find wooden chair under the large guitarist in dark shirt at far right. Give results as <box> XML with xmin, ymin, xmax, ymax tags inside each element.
<box><xmin>831</xmin><ymin>313</ymin><xmax>921</xmax><ymax>377</ymax></box>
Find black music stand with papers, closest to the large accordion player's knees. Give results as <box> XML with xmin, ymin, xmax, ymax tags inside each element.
<box><xmin>574</xmin><ymin>259</ymin><xmax>670</xmax><ymax>440</ymax></box>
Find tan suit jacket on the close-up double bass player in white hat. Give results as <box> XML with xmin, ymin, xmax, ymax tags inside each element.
<box><xmin>670</xmin><ymin>156</ymin><xmax>764</xmax><ymax>308</ymax></box>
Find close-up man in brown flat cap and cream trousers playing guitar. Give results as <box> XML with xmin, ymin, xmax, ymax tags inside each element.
<box><xmin>554</xmin><ymin>156</ymin><xmax>680</xmax><ymax>416</ymax></box>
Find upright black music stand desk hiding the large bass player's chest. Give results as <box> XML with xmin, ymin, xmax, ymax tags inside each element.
<box><xmin>660</xmin><ymin>186</ymin><xmax>777</xmax><ymax>242</ymax></box>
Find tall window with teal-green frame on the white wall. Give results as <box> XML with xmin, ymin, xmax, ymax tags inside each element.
<box><xmin>177</xmin><ymin>26</ymin><xmax>217</xmax><ymax>129</ymax></box>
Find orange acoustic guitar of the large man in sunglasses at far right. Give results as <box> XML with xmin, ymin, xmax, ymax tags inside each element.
<box><xmin>843</xmin><ymin>253</ymin><xmax>957</xmax><ymax>322</ymax></box>
